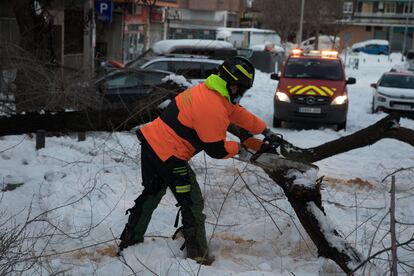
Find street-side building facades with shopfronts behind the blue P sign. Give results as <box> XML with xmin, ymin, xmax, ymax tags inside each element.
<box><xmin>0</xmin><ymin>0</ymin><xmax>246</xmax><ymax>69</ymax></box>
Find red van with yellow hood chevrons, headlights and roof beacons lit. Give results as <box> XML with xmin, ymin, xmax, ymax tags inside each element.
<box><xmin>271</xmin><ymin>49</ymin><xmax>356</xmax><ymax>130</ymax></box>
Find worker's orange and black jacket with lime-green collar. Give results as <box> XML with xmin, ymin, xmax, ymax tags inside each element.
<box><xmin>141</xmin><ymin>75</ymin><xmax>266</xmax><ymax>161</ymax></box>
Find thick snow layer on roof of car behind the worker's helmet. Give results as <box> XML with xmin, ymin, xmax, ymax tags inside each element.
<box><xmin>152</xmin><ymin>39</ymin><xmax>233</xmax><ymax>55</ymax></box>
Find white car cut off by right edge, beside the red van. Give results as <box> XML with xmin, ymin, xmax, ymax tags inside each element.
<box><xmin>371</xmin><ymin>72</ymin><xmax>414</xmax><ymax>114</ymax></box>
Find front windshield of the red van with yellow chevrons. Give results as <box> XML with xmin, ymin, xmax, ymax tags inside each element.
<box><xmin>285</xmin><ymin>58</ymin><xmax>342</xmax><ymax>80</ymax></box>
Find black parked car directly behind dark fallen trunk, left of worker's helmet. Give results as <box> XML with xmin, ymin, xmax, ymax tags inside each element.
<box><xmin>95</xmin><ymin>69</ymin><xmax>189</xmax><ymax>111</ymax></box>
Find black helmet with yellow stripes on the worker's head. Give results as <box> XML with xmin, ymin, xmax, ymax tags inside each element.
<box><xmin>219</xmin><ymin>56</ymin><xmax>254</xmax><ymax>102</ymax></box>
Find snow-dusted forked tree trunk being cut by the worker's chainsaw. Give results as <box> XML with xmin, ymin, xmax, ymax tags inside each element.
<box><xmin>231</xmin><ymin>114</ymin><xmax>414</xmax><ymax>274</ymax></box>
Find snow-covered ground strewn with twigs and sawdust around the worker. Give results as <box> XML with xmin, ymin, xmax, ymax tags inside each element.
<box><xmin>0</xmin><ymin>51</ymin><xmax>414</xmax><ymax>275</ymax></box>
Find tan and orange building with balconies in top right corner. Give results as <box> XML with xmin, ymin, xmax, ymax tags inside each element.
<box><xmin>340</xmin><ymin>0</ymin><xmax>414</xmax><ymax>51</ymax></box>
